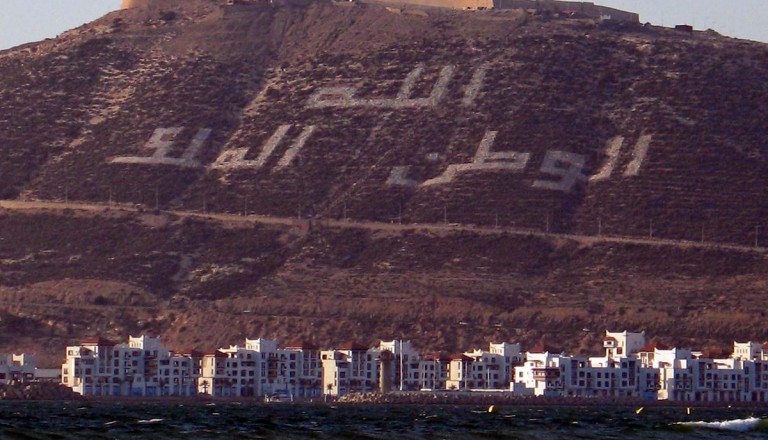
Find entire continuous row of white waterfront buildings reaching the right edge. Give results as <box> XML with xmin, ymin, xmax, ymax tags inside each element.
<box><xmin>61</xmin><ymin>332</ymin><xmax>768</xmax><ymax>402</ymax></box>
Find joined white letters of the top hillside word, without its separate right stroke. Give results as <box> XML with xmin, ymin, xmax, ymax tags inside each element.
<box><xmin>307</xmin><ymin>66</ymin><xmax>455</xmax><ymax>109</ymax></box>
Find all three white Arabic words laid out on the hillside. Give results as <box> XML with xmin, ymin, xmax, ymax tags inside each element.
<box><xmin>106</xmin><ymin>64</ymin><xmax>653</xmax><ymax>192</ymax></box>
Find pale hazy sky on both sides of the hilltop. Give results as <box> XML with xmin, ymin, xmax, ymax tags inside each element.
<box><xmin>0</xmin><ymin>0</ymin><xmax>768</xmax><ymax>49</ymax></box>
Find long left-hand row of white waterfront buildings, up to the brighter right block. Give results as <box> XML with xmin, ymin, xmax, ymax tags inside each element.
<box><xmin>61</xmin><ymin>336</ymin><xmax>523</xmax><ymax>398</ymax></box>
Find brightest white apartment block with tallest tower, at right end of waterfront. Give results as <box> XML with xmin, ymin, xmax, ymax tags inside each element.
<box><xmin>510</xmin><ymin>332</ymin><xmax>768</xmax><ymax>402</ymax></box>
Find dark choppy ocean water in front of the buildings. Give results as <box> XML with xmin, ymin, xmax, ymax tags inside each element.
<box><xmin>0</xmin><ymin>402</ymin><xmax>768</xmax><ymax>440</ymax></box>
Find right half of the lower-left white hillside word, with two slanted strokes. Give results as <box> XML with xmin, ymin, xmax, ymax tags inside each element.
<box><xmin>212</xmin><ymin>124</ymin><xmax>315</xmax><ymax>170</ymax></box>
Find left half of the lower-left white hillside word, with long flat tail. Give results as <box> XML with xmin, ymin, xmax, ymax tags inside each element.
<box><xmin>111</xmin><ymin>127</ymin><xmax>212</xmax><ymax>168</ymax></box>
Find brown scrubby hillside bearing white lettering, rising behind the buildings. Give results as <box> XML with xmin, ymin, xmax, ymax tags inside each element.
<box><xmin>0</xmin><ymin>0</ymin><xmax>768</xmax><ymax>364</ymax></box>
